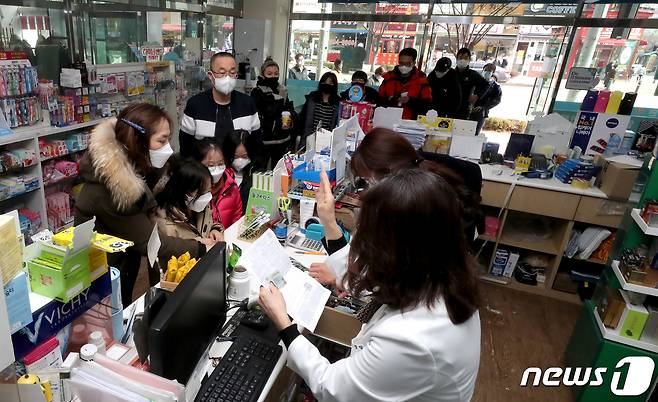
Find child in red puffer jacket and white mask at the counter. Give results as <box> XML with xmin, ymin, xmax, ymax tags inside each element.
<box><xmin>192</xmin><ymin>138</ymin><xmax>242</xmax><ymax>228</ymax></box>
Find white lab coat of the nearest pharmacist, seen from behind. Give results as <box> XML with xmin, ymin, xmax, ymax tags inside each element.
<box><xmin>288</xmin><ymin>302</ymin><xmax>480</xmax><ymax>402</ymax></box>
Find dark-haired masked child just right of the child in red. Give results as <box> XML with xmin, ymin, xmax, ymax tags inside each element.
<box><xmin>222</xmin><ymin>130</ymin><xmax>254</xmax><ymax>214</ymax></box>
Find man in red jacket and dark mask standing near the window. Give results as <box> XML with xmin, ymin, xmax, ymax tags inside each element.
<box><xmin>379</xmin><ymin>47</ymin><xmax>432</xmax><ymax>120</ymax></box>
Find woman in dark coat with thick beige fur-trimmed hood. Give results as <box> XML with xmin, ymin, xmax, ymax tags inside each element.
<box><xmin>75</xmin><ymin>104</ymin><xmax>206</xmax><ymax>305</ymax></box>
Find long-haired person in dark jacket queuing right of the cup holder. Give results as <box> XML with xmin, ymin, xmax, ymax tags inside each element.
<box><xmin>299</xmin><ymin>72</ymin><xmax>340</xmax><ymax>147</ymax></box>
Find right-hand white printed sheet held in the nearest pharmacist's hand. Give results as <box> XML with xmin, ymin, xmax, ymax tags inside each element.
<box><xmin>281</xmin><ymin>269</ymin><xmax>331</xmax><ymax>332</ymax></box>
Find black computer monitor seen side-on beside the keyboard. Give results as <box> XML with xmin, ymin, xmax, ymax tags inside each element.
<box><xmin>149</xmin><ymin>243</ymin><xmax>226</xmax><ymax>384</ymax></box>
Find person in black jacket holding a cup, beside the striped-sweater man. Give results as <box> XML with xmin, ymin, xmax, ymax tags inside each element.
<box><xmin>251</xmin><ymin>58</ymin><xmax>296</xmax><ymax>169</ymax></box>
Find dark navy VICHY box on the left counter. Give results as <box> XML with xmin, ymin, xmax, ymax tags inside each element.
<box><xmin>11</xmin><ymin>271</ymin><xmax>112</xmax><ymax>360</ymax></box>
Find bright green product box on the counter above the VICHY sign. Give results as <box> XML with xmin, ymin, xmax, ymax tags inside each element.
<box><xmin>27</xmin><ymin>244</ymin><xmax>91</xmax><ymax>303</ymax></box>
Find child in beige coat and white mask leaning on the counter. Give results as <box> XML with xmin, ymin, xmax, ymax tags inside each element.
<box><xmin>153</xmin><ymin>158</ymin><xmax>224</xmax><ymax>241</ymax></box>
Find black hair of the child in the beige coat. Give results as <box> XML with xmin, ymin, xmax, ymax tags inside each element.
<box><xmin>155</xmin><ymin>157</ymin><xmax>212</xmax><ymax>218</ymax></box>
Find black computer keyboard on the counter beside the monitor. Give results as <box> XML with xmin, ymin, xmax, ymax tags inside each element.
<box><xmin>195</xmin><ymin>336</ymin><xmax>283</xmax><ymax>402</ymax></box>
